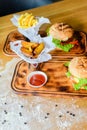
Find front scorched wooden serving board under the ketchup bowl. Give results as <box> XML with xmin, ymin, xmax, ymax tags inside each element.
<box><xmin>11</xmin><ymin>60</ymin><xmax>87</xmax><ymax>96</ymax></box>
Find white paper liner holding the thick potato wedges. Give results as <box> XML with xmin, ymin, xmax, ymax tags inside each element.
<box><xmin>10</xmin><ymin>40</ymin><xmax>53</xmax><ymax>64</ymax></box>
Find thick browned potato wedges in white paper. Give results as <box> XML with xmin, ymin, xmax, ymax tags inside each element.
<box><xmin>21</xmin><ymin>41</ymin><xmax>45</xmax><ymax>58</ymax></box>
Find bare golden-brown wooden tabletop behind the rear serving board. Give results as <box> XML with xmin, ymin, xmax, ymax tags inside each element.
<box><xmin>0</xmin><ymin>0</ymin><xmax>87</xmax><ymax>66</ymax></box>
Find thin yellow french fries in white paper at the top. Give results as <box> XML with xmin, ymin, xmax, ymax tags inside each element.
<box><xmin>18</xmin><ymin>13</ymin><xmax>37</xmax><ymax>28</ymax></box>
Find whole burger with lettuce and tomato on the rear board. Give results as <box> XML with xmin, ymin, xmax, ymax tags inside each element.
<box><xmin>48</xmin><ymin>23</ymin><xmax>80</xmax><ymax>52</ymax></box>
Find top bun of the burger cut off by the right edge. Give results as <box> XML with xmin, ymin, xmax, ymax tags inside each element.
<box><xmin>69</xmin><ymin>56</ymin><xmax>87</xmax><ymax>78</ymax></box>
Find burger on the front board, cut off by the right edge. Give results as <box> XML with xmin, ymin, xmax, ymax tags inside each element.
<box><xmin>66</xmin><ymin>56</ymin><xmax>87</xmax><ymax>90</ymax></box>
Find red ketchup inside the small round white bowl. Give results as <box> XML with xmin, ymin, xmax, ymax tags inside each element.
<box><xmin>30</xmin><ymin>74</ymin><xmax>45</xmax><ymax>86</ymax></box>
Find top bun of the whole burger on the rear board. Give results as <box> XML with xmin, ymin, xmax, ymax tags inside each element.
<box><xmin>49</xmin><ymin>23</ymin><xmax>74</xmax><ymax>41</ymax></box>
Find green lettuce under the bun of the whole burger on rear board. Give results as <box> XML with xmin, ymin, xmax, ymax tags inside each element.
<box><xmin>52</xmin><ymin>38</ymin><xmax>74</xmax><ymax>52</ymax></box>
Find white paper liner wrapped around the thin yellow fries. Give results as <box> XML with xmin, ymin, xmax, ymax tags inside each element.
<box><xmin>11</xmin><ymin>15</ymin><xmax>50</xmax><ymax>42</ymax></box>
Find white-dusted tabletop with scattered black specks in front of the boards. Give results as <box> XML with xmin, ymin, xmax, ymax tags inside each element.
<box><xmin>0</xmin><ymin>58</ymin><xmax>87</xmax><ymax>130</ymax></box>
